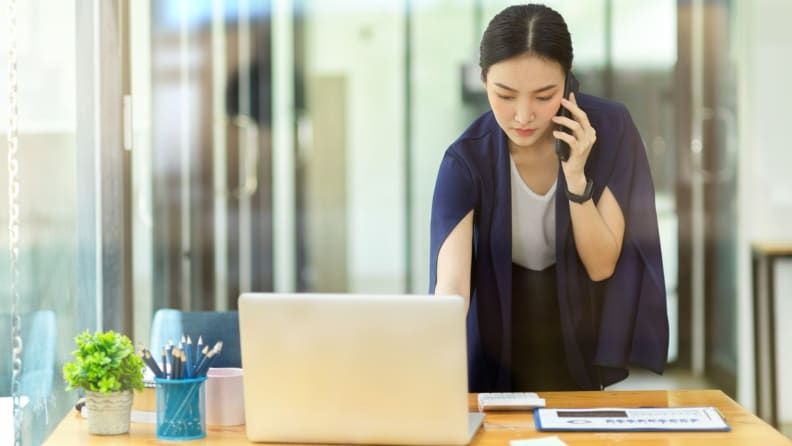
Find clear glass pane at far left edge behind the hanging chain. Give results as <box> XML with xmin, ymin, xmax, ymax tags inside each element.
<box><xmin>0</xmin><ymin>0</ymin><xmax>78</xmax><ymax>445</ymax></box>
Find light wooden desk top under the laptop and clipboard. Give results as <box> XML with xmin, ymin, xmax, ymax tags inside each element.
<box><xmin>44</xmin><ymin>390</ymin><xmax>792</xmax><ymax>446</ymax></box>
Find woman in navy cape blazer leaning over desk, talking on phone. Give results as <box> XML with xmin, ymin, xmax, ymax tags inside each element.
<box><xmin>430</xmin><ymin>5</ymin><xmax>668</xmax><ymax>392</ymax></box>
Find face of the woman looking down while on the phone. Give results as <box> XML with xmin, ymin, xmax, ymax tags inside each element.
<box><xmin>484</xmin><ymin>54</ymin><xmax>564</xmax><ymax>149</ymax></box>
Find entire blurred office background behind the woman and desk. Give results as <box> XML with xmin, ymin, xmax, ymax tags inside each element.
<box><xmin>0</xmin><ymin>0</ymin><xmax>792</xmax><ymax>444</ymax></box>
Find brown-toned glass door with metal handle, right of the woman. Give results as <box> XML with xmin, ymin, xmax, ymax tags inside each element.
<box><xmin>677</xmin><ymin>0</ymin><xmax>737</xmax><ymax>397</ymax></box>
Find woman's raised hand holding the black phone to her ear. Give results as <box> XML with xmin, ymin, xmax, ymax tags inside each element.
<box><xmin>553</xmin><ymin>93</ymin><xmax>597</xmax><ymax>179</ymax></box>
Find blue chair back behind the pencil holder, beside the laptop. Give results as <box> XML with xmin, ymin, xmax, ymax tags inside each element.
<box><xmin>149</xmin><ymin>308</ymin><xmax>242</xmax><ymax>367</ymax></box>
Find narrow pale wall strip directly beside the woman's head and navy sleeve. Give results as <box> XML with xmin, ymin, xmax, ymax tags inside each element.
<box><xmin>410</xmin><ymin>2</ymin><xmax>481</xmax><ymax>292</ymax></box>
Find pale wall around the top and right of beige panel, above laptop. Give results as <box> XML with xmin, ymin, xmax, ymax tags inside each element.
<box><xmin>304</xmin><ymin>0</ymin><xmax>405</xmax><ymax>292</ymax></box>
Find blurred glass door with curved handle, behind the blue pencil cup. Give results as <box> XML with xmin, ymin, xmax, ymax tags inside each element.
<box><xmin>130</xmin><ymin>0</ymin><xmax>273</xmax><ymax>335</ymax></box>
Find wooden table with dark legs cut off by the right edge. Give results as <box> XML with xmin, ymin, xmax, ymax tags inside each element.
<box><xmin>751</xmin><ymin>241</ymin><xmax>792</xmax><ymax>427</ymax></box>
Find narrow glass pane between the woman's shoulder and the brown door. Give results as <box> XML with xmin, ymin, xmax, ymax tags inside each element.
<box><xmin>601</xmin><ymin>0</ymin><xmax>684</xmax><ymax>361</ymax></box>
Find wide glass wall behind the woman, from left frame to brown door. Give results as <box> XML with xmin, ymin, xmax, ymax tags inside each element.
<box><xmin>131</xmin><ymin>0</ymin><xmax>676</xmax><ymax>352</ymax></box>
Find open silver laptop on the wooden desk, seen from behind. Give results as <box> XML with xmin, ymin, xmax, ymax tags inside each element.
<box><xmin>239</xmin><ymin>293</ymin><xmax>483</xmax><ymax>445</ymax></box>
